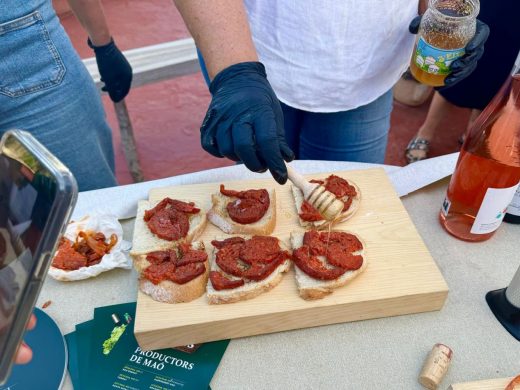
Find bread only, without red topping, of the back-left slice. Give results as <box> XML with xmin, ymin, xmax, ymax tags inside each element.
<box><xmin>130</xmin><ymin>200</ymin><xmax>207</xmax><ymax>262</ymax></box>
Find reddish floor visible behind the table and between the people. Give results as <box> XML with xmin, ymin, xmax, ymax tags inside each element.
<box><xmin>61</xmin><ymin>0</ymin><xmax>466</xmax><ymax>184</ymax></box>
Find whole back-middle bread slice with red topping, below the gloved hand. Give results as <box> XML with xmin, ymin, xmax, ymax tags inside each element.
<box><xmin>208</xmin><ymin>185</ymin><xmax>276</xmax><ymax>235</ymax></box>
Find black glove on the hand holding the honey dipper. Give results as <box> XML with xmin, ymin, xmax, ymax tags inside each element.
<box><xmin>200</xmin><ymin>62</ymin><xmax>294</xmax><ymax>184</ymax></box>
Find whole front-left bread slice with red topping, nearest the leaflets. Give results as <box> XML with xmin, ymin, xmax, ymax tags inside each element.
<box><xmin>139</xmin><ymin>241</ymin><xmax>209</xmax><ymax>303</ymax></box>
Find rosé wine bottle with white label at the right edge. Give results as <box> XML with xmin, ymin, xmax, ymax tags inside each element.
<box><xmin>439</xmin><ymin>53</ymin><xmax>520</xmax><ymax>241</ymax></box>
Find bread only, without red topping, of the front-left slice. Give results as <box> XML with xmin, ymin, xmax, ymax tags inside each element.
<box><xmin>139</xmin><ymin>241</ymin><xmax>209</xmax><ymax>303</ymax></box>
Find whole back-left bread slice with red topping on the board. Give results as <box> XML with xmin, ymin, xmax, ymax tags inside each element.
<box><xmin>130</xmin><ymin>198</ymin><xmax>206</xmax><ymax>258</ymax></box>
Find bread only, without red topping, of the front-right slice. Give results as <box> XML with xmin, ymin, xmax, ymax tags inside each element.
<box><xmin>291</xmin><ymin>232</ymin><xmax>368</xmax><ymax>300</ymax></box>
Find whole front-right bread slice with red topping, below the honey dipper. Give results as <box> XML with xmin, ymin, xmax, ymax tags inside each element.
<box><xmin>291</xmin><ymin>230</ymin><xmax>367</xmax><ymax>300</ymax></box>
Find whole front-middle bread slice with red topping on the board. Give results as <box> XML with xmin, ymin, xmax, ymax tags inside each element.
<box><xmin>206</xmin><ymin>236</ymin><xmax>291</xmax><ymax>304</ymax></box>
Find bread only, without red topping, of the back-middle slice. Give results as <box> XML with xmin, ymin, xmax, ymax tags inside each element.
<box><xmin>208</xmin><ymin>188</ymin><xmax>276</xmax><ymax>236</ymax></box>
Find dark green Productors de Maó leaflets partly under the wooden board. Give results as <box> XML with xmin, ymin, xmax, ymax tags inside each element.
<box><xmin>65</xmin><ymin>303</ymin><xmax>229</xmax><ymax>390</ymax></box>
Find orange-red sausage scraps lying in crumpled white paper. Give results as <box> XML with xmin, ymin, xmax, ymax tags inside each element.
<box><xmin>52</xmin><ymin>231</ymin><xmax>117</xmax><ymax>271</ymax></box>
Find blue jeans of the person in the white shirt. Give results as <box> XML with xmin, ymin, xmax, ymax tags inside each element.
<box><xmin>197</xmin><ymin>51</ymin><xmax>393</xmax><ymax>164</ymax></box>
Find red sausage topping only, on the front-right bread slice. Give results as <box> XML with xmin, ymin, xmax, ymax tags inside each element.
<box><xmin>293</xmin><ymin>230</ymin><xmax>363</xmax><ymax>280</ymax></box>
